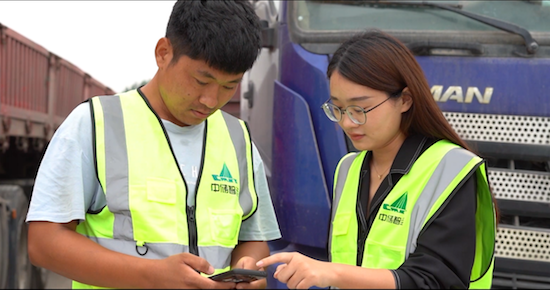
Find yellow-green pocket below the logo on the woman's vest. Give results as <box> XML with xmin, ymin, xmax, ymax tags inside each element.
<box><xmin>363</xmin><ymin>238</ymin><xmax>405</xmax><ymax>270</ymax></box>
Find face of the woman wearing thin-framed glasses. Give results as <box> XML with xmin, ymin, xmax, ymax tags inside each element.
<box><xmin>330</xmin><ymin>71</ymin><xmax>411</xmax><ymax>150</ymax></box>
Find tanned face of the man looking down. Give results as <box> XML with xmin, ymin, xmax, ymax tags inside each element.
<box><xmin>158</xmin><ymin>55</ymin><xmax>244</xmax><ymax>126</ymax></box>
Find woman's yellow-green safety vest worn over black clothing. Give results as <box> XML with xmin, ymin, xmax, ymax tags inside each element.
<box><xmin>329</xmin><ymin>141</ymin><xmax>496</xmax><ymax>288</ymax></box>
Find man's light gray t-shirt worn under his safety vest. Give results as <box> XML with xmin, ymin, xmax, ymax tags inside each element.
<box><xmin>27</xmin><ymin>103</ymin><xmax>281</xmax><ymax>241</ymax></box>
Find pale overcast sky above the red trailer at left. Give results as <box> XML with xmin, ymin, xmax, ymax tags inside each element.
<box><xmin>0</xmin><ymin>0</ymin><xmax>175</xmax><ymax>92</ymax></box>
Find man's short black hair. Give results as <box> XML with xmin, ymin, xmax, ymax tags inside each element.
<box><xmin>166</xmin><ymin>0</ymin><xmax>261</xmax><ymax>74</ymax></box>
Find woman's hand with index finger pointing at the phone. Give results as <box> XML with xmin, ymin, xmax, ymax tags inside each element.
<box><xmin>256</xmin><ymin>253</ymin><xmax>334</xmax><ymax>289</ymax></box>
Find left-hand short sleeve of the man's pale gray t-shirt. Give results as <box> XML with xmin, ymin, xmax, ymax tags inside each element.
<box><xmin>27</xmin><ymin>103</ymin><xmax>101</xmax><ymax>223</ymax></box>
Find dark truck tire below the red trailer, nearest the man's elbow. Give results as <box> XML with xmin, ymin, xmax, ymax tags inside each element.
<box><xmin>0</xmin><ymin>185</ymin><xmax>32</xmax><ymax>289</ymax></box>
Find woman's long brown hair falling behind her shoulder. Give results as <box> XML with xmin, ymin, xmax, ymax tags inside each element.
<box><xmin>327</xmin><ymin>30</ymin><xmax>498</xmax><ymax>220</ymax></box>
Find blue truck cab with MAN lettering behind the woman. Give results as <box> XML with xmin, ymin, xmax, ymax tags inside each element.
<box><xmin>240</xmin><ymin>0</ymin><xmax>550</xmax><ymax>288</ymax></box>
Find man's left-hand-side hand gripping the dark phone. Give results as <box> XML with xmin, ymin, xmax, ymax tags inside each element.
<box><xmin>150</xmin><ymin>253</ymin><xmax>235</xmax><ymax>289</ymax></box>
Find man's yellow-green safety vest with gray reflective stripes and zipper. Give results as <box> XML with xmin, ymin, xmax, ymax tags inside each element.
<box><xmin>73</xmin><ymin>90</ymin><xmax>258</xmax><ymax>288</ymax></box>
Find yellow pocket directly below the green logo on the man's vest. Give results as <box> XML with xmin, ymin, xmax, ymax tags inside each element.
<box><xmin>209</xmin><ymin>209</ymin><xmax>241</xmax><ymax>246</ymax></box>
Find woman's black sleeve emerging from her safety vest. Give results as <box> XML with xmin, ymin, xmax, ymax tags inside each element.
<box><xmin>395</xmin><ymin>174</ymin><xmax>477</xmax><ymax>289</ymax></box>
